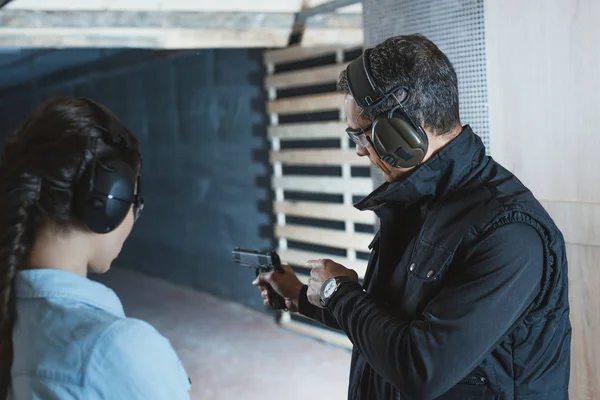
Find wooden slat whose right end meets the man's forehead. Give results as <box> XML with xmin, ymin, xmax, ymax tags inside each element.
<box><xmin>267</xmin><ymin>93</ymin><xmax>344</xmax><ymax>114</ymax></box>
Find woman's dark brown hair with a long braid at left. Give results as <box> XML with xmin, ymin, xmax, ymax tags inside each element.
<box><xmin>0</xmin><ymin>97</ymin><xmax>141</xmax><ymax>400</ymax></box>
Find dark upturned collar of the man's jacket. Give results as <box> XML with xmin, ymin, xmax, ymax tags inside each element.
<box><xmin>355</xmin><ymin>125</ymin><xmax>486</xmax><ymax>212</ymax></box>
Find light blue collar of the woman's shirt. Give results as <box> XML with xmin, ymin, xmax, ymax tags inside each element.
<box><xmin>15</xmin><ymin>269</ymin><xmax>125</xmax><ymax>317</ymax></box>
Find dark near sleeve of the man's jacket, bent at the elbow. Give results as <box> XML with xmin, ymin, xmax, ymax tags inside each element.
<box><xmin>329</xmin><ymin>223</ymin><xmax>544</xmax><ymax>399</ymax></box>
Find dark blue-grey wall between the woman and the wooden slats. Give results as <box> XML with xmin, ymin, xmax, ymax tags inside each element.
<box><xmin>0</xmin><ymin>49</ymin><xmax>272</xmax><ymax>309</ymax></box>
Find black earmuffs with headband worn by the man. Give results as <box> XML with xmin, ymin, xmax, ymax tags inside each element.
<box><xmin>346</xmin><ymin>49</ymin><xmax>428</xmax><ymax>168</ymax></box>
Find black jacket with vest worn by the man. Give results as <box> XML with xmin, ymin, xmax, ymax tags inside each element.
<box><xmin>299</xmin><ymin>125</ymin><xmax>571</xmax><ymax>400</ymax></box>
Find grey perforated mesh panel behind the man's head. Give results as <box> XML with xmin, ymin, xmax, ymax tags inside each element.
<box><xmin>363</xmin><ymin>0</ymin><xmax>489</xmax><ymax>189</ymax></box>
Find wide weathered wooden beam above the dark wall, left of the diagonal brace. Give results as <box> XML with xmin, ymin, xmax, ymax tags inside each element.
<box><xmin>0</xmin><ymin>10</ymin><xmax>293</xmax><ymax>49</ymax></box>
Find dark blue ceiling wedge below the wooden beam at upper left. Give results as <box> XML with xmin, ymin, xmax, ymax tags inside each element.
<box><xmin>0</xmin><ymin>48</ymin><xmax>123</xmax><ymax>89</ymax></box>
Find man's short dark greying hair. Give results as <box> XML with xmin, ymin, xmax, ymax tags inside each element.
<box><xmin>337</xmin><ymin>34</ymin><xmax>460</xmax><ymax>135</ymax></box>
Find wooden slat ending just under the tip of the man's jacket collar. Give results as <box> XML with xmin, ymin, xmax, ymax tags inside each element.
<box><xmin>273</xmin><ymin>201</ymin><xmax>375</xmax><ymax>224</ymax></box>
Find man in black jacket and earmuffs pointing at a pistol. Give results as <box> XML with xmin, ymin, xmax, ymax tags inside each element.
<box><xmin>254</xmin><ymin>35</ymin><xmax>571</xmax><ymax>400</ymax></box>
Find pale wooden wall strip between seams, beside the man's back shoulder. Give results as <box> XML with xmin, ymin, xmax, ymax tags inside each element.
<box><xmin>541</xmin><ymin>200</ymin><xmax>600</xmax><ymax>246</ymax></box>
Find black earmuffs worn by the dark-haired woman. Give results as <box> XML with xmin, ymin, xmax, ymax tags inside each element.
<box><xmin>74</xmin><ymin>99</ymin><xmax>144</xmax><ymax>233</ymax></box>
